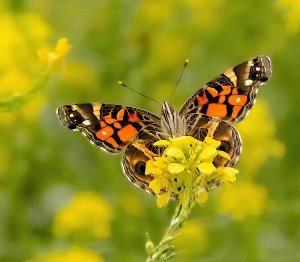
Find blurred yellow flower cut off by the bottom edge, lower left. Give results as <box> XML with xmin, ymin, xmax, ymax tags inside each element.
<box><xmin>27</xmin><ymin>247</ymin><xmax>104</xmax><ymax>262</ymax></box>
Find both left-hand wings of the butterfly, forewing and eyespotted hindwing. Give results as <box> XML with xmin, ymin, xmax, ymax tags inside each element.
<box><xmin>57</xmin><ymin>103</ymin><xmax>161</xmax><ymax>191</ymax></box>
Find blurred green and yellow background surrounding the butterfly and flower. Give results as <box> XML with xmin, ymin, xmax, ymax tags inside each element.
<box><xmin>0</xmin><ymin>0</ymin><xmax>300</xmax><ymax>262</ymax></box>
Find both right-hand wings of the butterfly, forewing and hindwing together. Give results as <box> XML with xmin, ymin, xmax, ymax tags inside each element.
<box><xmin>179</xmin><ymin>56</ymin><xmax>272</xmax><ymax>166</ymax></box>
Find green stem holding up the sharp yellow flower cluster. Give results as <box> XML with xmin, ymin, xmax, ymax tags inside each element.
<box><xmin>146</xmin><ymin>183</ymin><xmax>195</xmax><ymax>262</ymax></box>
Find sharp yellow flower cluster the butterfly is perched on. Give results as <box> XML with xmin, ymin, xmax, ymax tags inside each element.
<box><xmin>145</xmin><ymin>136</ymin><xmax>238</xmax><ymax>207</ymax></box>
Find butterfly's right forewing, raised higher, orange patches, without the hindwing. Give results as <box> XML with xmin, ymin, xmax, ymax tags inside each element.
<box><xmin>180</xmin><ymin>56</ymin><xmax>272</xmax><ymax>123</ymax></box>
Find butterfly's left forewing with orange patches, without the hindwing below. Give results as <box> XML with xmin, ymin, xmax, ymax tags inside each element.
<box><xmin>57</xmin><ymin>103</ymin><xmax>160</xmax><ymax>153</ymax></box>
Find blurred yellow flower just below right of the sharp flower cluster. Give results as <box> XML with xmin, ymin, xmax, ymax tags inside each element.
<box><xmin>218</xmin><ymin>182</ymin><xmax>267</xmax><ymax>220</ymax></box>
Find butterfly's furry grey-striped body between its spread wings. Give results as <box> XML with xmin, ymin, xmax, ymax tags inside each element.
<box><xmin>161</xmin><ymin>101</ymin><xmax>186</xmax><ymax>136</ymax></box>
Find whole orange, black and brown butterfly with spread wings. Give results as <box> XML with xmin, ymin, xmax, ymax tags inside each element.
<box><xmin>57</xmin><ymin>56</ymin><xmax>272</xmax><ymax>193</ymax></box>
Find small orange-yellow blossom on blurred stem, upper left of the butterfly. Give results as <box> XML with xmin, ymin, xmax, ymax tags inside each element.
<box><xmin>37</xmin><ymin>38</ymin><xmax>72</xmax><ymax>69</ymax></box>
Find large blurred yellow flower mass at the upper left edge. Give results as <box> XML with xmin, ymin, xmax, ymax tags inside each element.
<box><xmin>0</xmin><ymin>7</ymin><xmax>51</xmax><ymax>99</ymax></box>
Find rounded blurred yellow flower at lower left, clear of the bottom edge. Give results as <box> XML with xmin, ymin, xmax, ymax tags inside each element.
<box><xmin>54</xmin><ymin>192</ymin><xmax>112</xmax><ymax>238</ymax></box>
